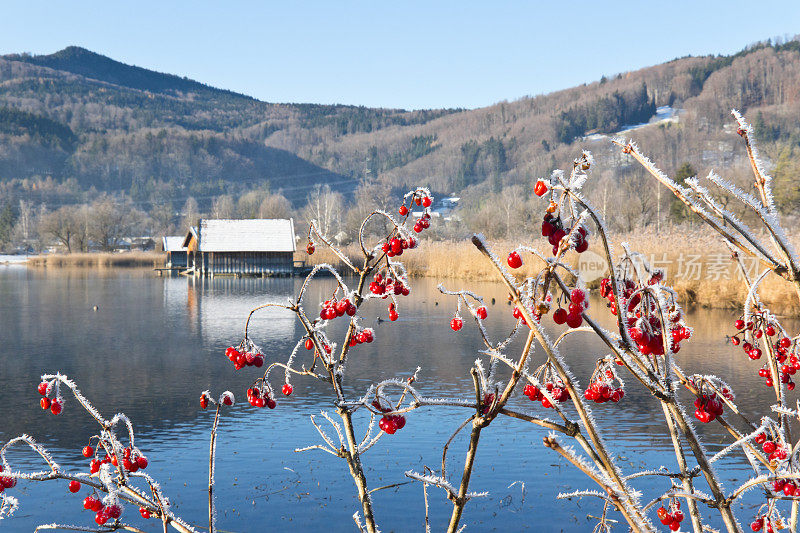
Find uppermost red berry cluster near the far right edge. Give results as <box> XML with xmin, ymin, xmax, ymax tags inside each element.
<box><xmin>731</xmin><ymin>316</ymin><xmax>800</xmax><ymax>390</ymax></box>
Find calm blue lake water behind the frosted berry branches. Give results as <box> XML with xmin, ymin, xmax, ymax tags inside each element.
<box><xmin>0</xmin><ymin>266</ymin><xmax>792</xmax><ymax>531</ymax></box>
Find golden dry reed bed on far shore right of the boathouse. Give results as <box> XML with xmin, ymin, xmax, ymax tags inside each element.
<box><xmin>297</xmin><ymin>230</ymin><xmax>800</xmax><ymax>316</ymax></box>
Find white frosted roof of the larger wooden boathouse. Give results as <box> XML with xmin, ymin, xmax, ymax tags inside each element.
<box><xmin>197</xmin><ymin>218</ymin><xmax>295</xmax><ymax>252</ymax></box>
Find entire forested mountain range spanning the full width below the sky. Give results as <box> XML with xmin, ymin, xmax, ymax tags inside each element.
<box><xmin>0</xmin><ymin>41</ymin><xmax>800</xmax><ymax>213</ymax></box>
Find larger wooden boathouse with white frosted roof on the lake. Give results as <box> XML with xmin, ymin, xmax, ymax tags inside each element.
<box><xmin>182</xmin><ymin>219</ymin><xmax>296</xmax><ymax>277</ymax></box>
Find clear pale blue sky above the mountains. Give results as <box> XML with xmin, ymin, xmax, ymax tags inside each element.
<box><xmin>0</xmin><ymin>0</ymin><xmax>800</xmax><ymax>109</ymax></box>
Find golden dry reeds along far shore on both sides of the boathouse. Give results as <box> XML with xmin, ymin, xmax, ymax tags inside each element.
<box><xmin>7</xmin><ymin>232</ymin><xmax>800</xmax><ymax>316</ymax></box>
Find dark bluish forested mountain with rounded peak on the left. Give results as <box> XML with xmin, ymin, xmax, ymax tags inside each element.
<box><xmin>0</xmin><ymin>46</ymin><xmax>448</xmax><ymax>203</ymax></box>
